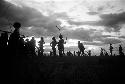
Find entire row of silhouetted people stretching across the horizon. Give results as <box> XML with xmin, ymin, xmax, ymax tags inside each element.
<box><xmin>0</xmin><ymin>22</ymin><xmax>124</xmax><ymax>56</ymax></box>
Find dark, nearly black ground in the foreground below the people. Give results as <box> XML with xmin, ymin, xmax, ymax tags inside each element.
<box><xmin>11</xmin><ymin>57</ymin><xmax>125</xmax><ymax>84</ymax></box>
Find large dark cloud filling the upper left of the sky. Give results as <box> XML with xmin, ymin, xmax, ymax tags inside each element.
<box><xmin>0</xmin><ymin>0</ymin><xmax>60</xmax><ymax>35</ymax></box>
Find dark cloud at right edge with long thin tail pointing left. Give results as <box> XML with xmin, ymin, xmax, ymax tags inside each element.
<box><xmin>68</xmin><ymin>12</ymin><xmax>125</xmax><ymax>31</ymax></box>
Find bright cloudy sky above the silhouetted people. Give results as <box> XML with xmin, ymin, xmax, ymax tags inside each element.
<box><xmin>0</xmin><ymin>0</ymin><xmax>125</xmax><ymax>54</ymax></box>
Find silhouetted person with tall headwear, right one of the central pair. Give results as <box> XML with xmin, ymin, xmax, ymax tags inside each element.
<box><xmin>58</xmin><ymin>34</ymin><xmax>66</xmax><ymax>56</ymax></box>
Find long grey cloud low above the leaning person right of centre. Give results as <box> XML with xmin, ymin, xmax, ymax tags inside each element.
<box><xmin>63</xmin><ymin>28</ymin><xmax>121</xmax><ymax>46</ymax></box>
